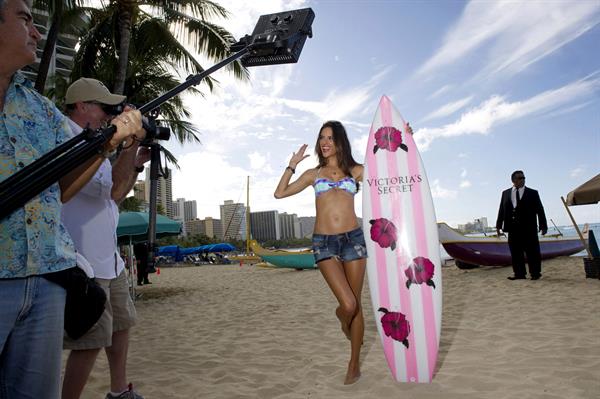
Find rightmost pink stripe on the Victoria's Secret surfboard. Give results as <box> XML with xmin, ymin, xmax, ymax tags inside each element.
<box><xmin>405</xmin><ymin>121</ymin><xmax>440</xmax><ymax>381</ymax></box>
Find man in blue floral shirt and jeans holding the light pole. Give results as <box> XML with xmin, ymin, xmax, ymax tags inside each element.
<box><xmin>0</xmin><ymin>0</ymin><xmax>144</xmax><ymax>399</ymax></box>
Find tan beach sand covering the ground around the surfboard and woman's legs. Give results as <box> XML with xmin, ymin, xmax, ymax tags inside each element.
<box><xmin>71</xmin><ymin>258</ymin><xmax>600</xmax><ymax>399</ymax></box>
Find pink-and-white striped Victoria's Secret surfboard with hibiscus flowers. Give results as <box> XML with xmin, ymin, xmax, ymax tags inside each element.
<box><xmin>362</xmin><ymin>96</ymin><xmax>442</xmax><ymax>383</ymax></box>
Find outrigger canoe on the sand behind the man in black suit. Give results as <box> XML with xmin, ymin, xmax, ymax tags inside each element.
<box><xmin>438</xmin><ymin>223</ymin><xmax>585</xmax><ymax>267</ymax></box>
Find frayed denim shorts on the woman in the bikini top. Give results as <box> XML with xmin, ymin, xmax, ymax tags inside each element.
<box><xmin>312</xmin><ymin>227</ymin><xmax>367</xmax><ymax>263</ymax></box>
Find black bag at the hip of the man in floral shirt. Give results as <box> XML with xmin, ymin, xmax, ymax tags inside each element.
<box><xmin>43</xmin><ymin>267</ymin><xmax>106</xmax><ymax>339</ymax></box>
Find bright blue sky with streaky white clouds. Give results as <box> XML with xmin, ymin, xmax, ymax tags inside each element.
<box><xmin>165</xmin><ymin>0</ymin><xmax>600</xmax><ymax>226</ymax></box>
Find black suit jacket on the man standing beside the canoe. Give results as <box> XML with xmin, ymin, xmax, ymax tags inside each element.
<box><xmin>496</xmin><ymin>187</ymin><xmax>548</xmax><ymax>234</ymax></box>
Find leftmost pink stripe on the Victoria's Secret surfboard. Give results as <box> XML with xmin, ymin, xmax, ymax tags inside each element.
<box><xmin>365</xmin><ymin>118</ymin><xmax>396</xmax><ymax>379</ymax></box>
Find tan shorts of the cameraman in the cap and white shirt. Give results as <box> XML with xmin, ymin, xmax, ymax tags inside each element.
<box><xmin>63</xmin><ymin>270</ymin><xmax>137</xmax><ymax>349</ymax></box>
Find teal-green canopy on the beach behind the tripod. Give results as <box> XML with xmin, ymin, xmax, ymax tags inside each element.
<box><xmin>117</xmin><ymin>212</ymin><xmax>181</xmax><ymax>244</ymax></box>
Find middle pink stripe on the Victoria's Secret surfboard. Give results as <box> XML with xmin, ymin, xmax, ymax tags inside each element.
<box><xmin>379</xmin><ymin>96</ymin><xmax>419</xmax><ymax>381</ymax></box>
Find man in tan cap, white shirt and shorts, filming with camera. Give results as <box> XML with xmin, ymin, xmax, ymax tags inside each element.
<box><xmin>62</xmin><ymin>78</ymin><xmax>150</xmax><ymax>399</ymax></box>
